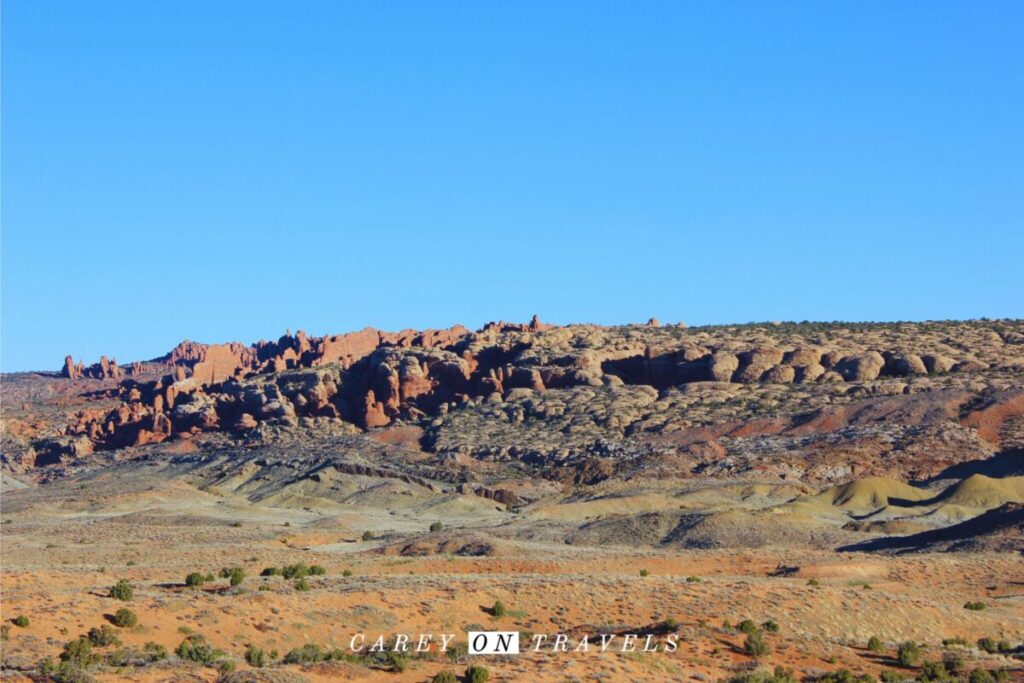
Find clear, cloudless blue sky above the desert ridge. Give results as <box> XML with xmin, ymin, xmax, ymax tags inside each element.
<box><xmin>2</xmin><ymin>0</ymin><xmax>1024</xmax><ymax>371</ymax></box>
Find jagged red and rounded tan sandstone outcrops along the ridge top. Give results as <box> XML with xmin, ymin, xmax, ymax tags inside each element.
<box><xmin>46</xmin><ymin>316</ymin><xmax>1016</xmax><ymax>456</ymax></box>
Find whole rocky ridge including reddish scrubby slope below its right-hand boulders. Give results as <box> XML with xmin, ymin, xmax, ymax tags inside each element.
<box><xmin>4</xmin><ymin>316</ymin><xmax>1024</xmax><ymax>482</ymax></box>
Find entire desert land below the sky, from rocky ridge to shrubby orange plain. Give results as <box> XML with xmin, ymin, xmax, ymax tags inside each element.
<box><xmin>0</xmin><ymin>316</ymin><xmax>1024</xmax><ymax>683</ymax></box>
